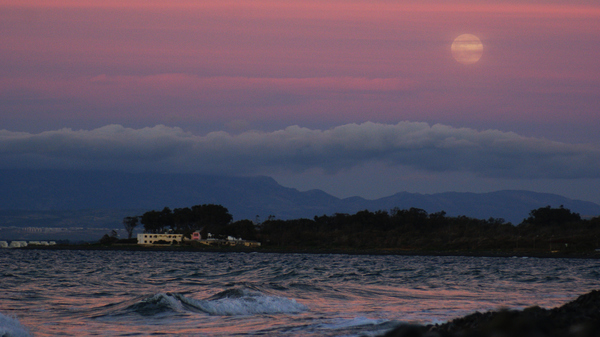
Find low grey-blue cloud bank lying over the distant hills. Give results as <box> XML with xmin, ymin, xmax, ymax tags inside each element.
<box><xmin>0</xmin><ymin>122</ymin><xmax>600</xmax><ymax>179</ymax></box>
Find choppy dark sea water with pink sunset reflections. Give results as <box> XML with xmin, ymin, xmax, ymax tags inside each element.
<box><xmin>0</xmin><ymin>249</ymin><xmax>600</xmax><ymax>336</ymax></box>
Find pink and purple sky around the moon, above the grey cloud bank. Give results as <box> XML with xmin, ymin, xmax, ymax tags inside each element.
<box><xmin>0</xmin><ymin>0</ymin><xmax>600</xmax><ymax>200</ymax></box>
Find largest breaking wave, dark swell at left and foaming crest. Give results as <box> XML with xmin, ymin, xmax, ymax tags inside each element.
<box><xmin>126</xmin><ymin>289</ymin><xmax>308</xmax><ymax>316</ymax></box>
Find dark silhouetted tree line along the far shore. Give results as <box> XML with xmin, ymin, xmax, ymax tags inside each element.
<box><xmin>126</xmin><ymin>205</ymin><xmax>600</xmax><ymax>251</ymax></box>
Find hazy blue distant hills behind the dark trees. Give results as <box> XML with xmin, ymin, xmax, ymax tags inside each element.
<box><xmin>0</xmin><ymin>170</ymin><xmax>600</xmax><ymax>225</ymax></box>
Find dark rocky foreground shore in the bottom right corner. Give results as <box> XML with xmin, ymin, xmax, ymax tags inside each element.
<box><xmin>384</xmin><ymin>290</ymin><xmax>600</xmax><ymax>337</ymax></box>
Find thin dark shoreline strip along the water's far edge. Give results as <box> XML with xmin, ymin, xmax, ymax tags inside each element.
<box><xmin>15</xmin><ymin>244</ymin><xmax>600</xmax><ymax>259</ymax></box>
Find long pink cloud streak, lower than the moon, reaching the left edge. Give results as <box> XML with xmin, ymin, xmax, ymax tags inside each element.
<box><xmin>0</xmin><ymin>74</ymin><xmax>414</xmax><ymax>117</ymax></box>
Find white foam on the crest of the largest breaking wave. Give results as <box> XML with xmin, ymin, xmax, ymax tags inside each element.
<box><xmin>180</xmin><ymin>290</ymin><xmax>307</xmax><ymax>316</ymax></box>
